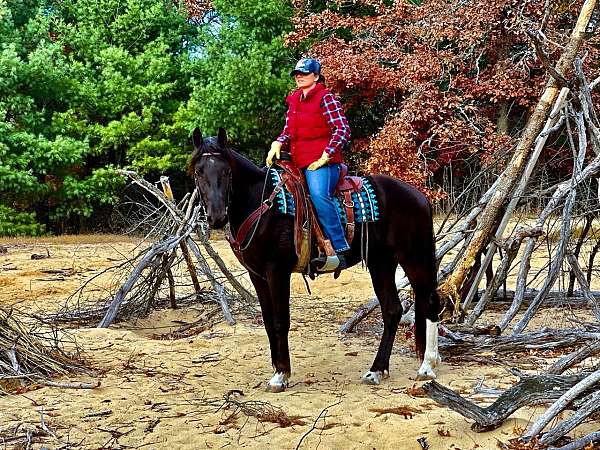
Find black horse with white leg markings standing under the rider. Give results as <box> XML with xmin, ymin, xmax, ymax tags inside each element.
<box><xmin>188</xmin><ymin>128</ymin><xmax>440</xmax><ymax>392</ymax></box>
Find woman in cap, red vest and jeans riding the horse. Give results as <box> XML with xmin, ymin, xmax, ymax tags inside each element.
<box><xmin>267</xmin><ymin>58</ymin><xmax>350</xmax><ymax>271</ymax></box>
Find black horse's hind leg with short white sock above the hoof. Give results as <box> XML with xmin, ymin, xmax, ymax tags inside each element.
<box><xmin>362</xmin><ymin>257</ymin><xmax>402</xmax><ymax>384</ymax></box>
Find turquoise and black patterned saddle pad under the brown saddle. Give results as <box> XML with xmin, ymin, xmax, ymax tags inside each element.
<box><xmin>269</xmin><ymin>168</ymin><xmax>379</xmax><ymax>224</ymax></box>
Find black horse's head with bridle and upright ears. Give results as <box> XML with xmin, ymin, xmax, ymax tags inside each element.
<box><xmin>188</xmin><ymin>127</ymin><xmax>232</xmax><ymax>229</ymax></box>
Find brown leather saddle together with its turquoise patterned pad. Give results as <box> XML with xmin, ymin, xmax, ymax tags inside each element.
<box><xmin>269</xmin><ymin>161</ymin><xmax>379</xmax><ymax>272</ymax></box>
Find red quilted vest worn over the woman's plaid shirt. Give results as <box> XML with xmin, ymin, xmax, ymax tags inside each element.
<box><xmin>286</xmin><ymin>83</ymin><xmax>342</xmax><ymax>169</ymax></box>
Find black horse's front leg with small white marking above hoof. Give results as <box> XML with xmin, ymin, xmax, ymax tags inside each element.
<box><xmin>266</xmin><ymin>265</ymin><xmax>292</xmax><ymax>392</ymax></box>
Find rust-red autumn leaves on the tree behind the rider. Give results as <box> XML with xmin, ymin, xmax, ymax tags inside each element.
<box><xmin>286</xmin><ymin>0</ymin><xmax>600</xmax><ymax>199</ymax></box>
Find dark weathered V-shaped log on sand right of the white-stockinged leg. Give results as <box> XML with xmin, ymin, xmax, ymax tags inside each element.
<box><xmin>423</xmin><ymin>374</ymin><xmax>586</xmax><ymax>433</ymax></box>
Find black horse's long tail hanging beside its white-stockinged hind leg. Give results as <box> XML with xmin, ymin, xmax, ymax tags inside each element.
<box><xmin>415</xmin><ymin>199</ymin><xmax>441</xmax><ymax>360</ymax></box>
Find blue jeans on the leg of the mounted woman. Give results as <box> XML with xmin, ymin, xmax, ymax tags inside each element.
<box><xmin>304</xmin><ymin>164</ymin><xmax>350</xmax><ymax>252</ymax></box>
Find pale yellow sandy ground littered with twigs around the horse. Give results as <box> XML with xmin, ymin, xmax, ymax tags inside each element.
<box><xmin>0</xmin><ymin>236</ymin><xmax>599</xmax><ymax>450</ymax></box>
